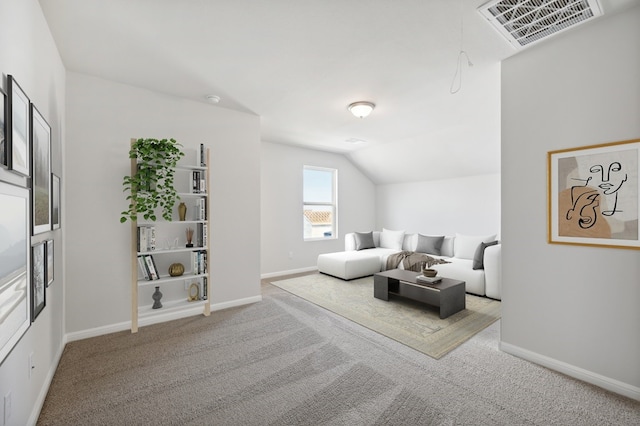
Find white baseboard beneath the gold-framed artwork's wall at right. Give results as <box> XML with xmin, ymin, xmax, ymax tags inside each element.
<box><xmin>500</xmin><ymin>342</ymin><xmax>640</xmax><ymax>401</ymax></box>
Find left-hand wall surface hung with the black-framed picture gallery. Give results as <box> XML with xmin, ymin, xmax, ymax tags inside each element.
<box><xmin>0</xmin><ymin>0</ymin><xmax>65</xmax><ymax>425</ymax></box>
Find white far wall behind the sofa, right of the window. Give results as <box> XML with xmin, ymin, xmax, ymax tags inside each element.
<box><xmin>376</xmin><ymin>174</ymin><xmax>500</xmax><ymax>235</ymax></box>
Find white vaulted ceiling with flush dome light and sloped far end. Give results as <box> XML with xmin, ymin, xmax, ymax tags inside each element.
<box><xmin>40</xmin><ymin>0</ymin><xmax>638</xmax><ymax>184</ymax></box>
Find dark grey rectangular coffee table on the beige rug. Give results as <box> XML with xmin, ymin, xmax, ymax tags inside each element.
<box><xmin>373</xmin><ymin>269</ymin><xmax>466</xmax><ymax>319</ymax></box>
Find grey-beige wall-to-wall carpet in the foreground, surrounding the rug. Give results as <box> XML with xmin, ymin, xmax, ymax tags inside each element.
<box><xmin>38</xmin><ymin>284</ymin><xmax>640</xmax><ymax>426</ymax></box>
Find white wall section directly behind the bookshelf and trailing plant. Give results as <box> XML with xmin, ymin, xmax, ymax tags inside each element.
<box><xmin>66</xmin><ymin>70</ymin><xmax>260</xmax><ymax>338</ymax></box>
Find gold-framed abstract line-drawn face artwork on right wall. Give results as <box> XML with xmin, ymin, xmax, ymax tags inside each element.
<box><xmin>547</xmin><ymin>139</ymin><xmax>640</xmax><ymax>249</ymax></box>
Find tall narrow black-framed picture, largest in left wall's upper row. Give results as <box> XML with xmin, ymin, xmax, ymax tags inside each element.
<box><xmin>31</xmin><ymin>104</ymin><xmax>51</xmax><ymax>235</ymax></box>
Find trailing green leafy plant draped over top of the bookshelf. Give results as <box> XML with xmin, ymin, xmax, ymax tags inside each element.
<box><xmin>120</xmin><ymin>139</ymin><xmax>184</xmax><ymax>223</ymax></box>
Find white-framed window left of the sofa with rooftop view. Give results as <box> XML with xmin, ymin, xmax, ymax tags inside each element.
<box><xmin>302</xmin><ymin>166</ymin><xmax>338</xmax><ymax>241</ymax></box>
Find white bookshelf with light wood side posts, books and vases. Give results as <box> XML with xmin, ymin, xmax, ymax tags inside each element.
<box><xmin>131</xmin><ymin>141</ymin><xmax>211</xmax><ymax>333</ymax></box>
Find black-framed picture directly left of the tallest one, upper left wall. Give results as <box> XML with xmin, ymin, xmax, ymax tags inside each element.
<box><xmin>5</xmin><ymin>75</ymin><xmax>31</xmax><ymax>176</ymax></box>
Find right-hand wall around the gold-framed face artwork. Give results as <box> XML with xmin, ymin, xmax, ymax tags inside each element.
<box><xmin>501</xmin><ymin>7</ymin><xmax>640</xmax><ymax>399</ymax></box>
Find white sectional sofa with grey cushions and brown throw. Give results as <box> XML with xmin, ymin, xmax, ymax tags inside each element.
<box><xmin>318</xmin><ymin>229</ymin><xmax>502</xmax><ymax>300</ymax></box>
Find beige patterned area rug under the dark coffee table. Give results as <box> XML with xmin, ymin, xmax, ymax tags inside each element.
<box><xmin>271</xmin><ymin>274</ymin><xmax>500</xmax><ymax>359</ymax></box>
